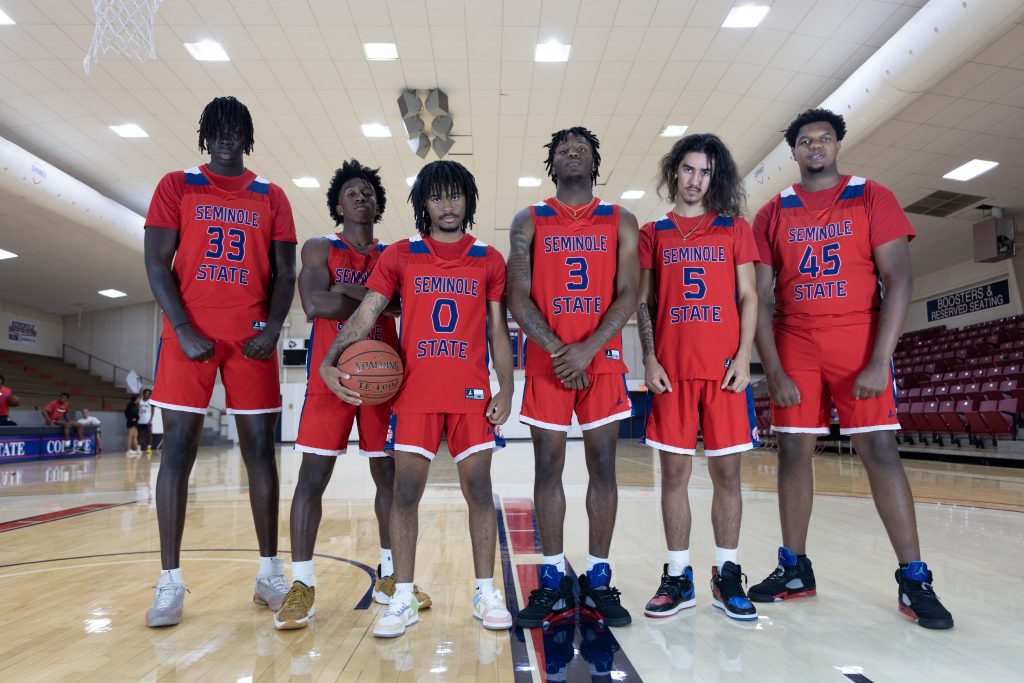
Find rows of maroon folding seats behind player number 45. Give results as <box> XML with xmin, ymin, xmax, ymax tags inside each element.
<box><xmin>755</xmin><ymin>315</ymin><xmax>1024</xmax><ymax>447</ymax></box>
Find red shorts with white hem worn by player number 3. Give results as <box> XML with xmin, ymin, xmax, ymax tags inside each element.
<box><xmin>519</xmin><ymin>374</ymin><xmax>633</xmax><ymax>432</ymax></box>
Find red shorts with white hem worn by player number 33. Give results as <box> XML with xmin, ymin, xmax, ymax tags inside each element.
<box><xmin>151</xmin><ymin>337</ymin><xmax>281</xmax><ymax>415</ymax></box>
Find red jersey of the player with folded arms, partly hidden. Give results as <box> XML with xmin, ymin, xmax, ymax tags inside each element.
<box><xmin>306</xmin><ymin>234</ymin><xmax>398</xmax><ymax>393</ymax></box>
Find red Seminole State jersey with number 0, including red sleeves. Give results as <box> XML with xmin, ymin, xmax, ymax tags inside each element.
<box><xmin>367</xmin><ymin>234</ymin><xmax>505</xmax><ymax>415</ymax></box>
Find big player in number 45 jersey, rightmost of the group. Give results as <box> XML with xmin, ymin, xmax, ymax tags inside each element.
<box><xmin>750</xmin><ymin>109</ymin><xmax>953</xmax><ymax>629</ymax></box>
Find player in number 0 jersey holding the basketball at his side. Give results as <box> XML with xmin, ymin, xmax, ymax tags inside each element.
<box><xmin>321</xmin><ymin>161</ymin><xmax>512</xmax><ymax>638</ymax></box>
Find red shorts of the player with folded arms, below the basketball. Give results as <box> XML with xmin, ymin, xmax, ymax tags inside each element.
<box><xmin>295</xmin><ymin>393</ymin><xmax>391</xmax><ymax>458</ymax></box>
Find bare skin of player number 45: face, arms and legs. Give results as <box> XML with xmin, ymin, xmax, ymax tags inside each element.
<box><xmin>757</xmin><ymin>122</ymin><xmax>921</xmax><ymax>564</ymax></box>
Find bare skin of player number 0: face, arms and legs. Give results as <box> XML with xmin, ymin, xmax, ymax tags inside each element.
<box><xmin>319</xmin><ymin>193</ymin><xmax>513</xmax><ymax>584</ymax></box>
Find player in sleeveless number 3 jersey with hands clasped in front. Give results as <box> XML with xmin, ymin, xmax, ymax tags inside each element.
<box><xmin>509</xmin><ymin>126</ymin><xmax>640</xmax><ymax>628</ymax></box>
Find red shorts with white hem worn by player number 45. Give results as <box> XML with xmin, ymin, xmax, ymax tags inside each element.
<box><xmin>771</xmin><ymin>325</ymin><xmax>900</xmax><ymax>434</ymax></box>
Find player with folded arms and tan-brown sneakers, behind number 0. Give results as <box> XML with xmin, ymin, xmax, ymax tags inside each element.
<box><xmin>274</xmin><ymin>159</ymin><xmax>430</xmax><ymax>629</ymax></box>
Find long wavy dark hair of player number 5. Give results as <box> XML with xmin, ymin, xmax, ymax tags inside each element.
<box><xmin>657</xmin><ymin>133</ymin><xmax>746</xmax><ymax>216</ymax></box>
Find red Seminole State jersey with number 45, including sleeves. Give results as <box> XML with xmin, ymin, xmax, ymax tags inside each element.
<box><xmin>754</xmin><ymin>176</ymin><xmax>914</xmax><ymax>329</ymax></box>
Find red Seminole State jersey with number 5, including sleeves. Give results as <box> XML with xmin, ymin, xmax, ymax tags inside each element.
<box><xmin>639</xmin><ymin>213</ymin><xmax>758</xmax><ymax>380</ymax></box>
